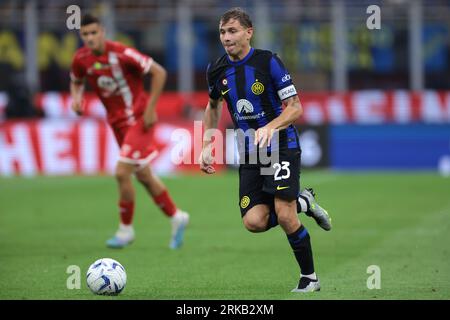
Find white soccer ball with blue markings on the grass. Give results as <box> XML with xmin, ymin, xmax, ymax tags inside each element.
<box><xmin>86</xmin><ymin>258</ymin><xmax>127</xmax><ymax>296</ymax></box>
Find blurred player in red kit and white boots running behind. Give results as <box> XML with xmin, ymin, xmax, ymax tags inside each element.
<box><xmin>70</xmin><ymin>15</ymin><xmax>189</xmax><ymax>249</ymax></box>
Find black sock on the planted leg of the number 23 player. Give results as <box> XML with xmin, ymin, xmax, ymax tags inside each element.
<box><xmin>287</xmin><ymin>225</ymin><xmax>314</xmax><ymax>275</ymax></box>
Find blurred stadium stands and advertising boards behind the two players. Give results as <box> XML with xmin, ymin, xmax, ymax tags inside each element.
<box><xmin>0</xmin><ymin>0</ymin><xmax>450</xmax><ymax>176</ymax></box>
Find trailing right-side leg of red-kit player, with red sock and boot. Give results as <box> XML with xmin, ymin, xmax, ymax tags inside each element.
<box><xmin>136</xmin><ymin>165</ymin><xmax>189</xmax><ymax>249</ymax></box>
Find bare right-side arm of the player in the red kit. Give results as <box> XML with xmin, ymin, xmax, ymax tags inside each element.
<box><xmin>144</xmin><ymin>61</ymin><xmax>167</xmax><ymax>128</ymax></box>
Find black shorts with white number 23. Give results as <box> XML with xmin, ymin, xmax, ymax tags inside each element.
<box><xmin>239</xmin><ymin>149</ymin><xmax>301</xmax><ymax>216</ymax></box>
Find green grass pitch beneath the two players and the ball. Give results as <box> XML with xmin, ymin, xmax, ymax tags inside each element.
<box><xmin>0</xmin><ymin>171</ymin><xmax>450</xmax><ymax>300</ymax></box>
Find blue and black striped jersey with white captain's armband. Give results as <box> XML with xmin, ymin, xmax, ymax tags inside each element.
<box><xmin>207</xmin><ymin>48</ymin><xmax>300</xmax><ymax>153</ymax></box>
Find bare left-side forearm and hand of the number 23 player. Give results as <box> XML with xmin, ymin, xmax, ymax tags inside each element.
<box><xmin>199</xmin><ymin>98</ymin><xmax>222</xmax><ymax>174</ymax></box>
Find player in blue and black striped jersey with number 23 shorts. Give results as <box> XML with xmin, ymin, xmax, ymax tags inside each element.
<box><xmin>200</xmin><ymin>8</ymin><xmax>331</xmax><ymax>292</ymax></box>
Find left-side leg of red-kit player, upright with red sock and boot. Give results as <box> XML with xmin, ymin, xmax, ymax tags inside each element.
<box><xmin>106</xmin><ymin>161</ymin><xmax>135</xmax><ymax>248</ymax></box>
